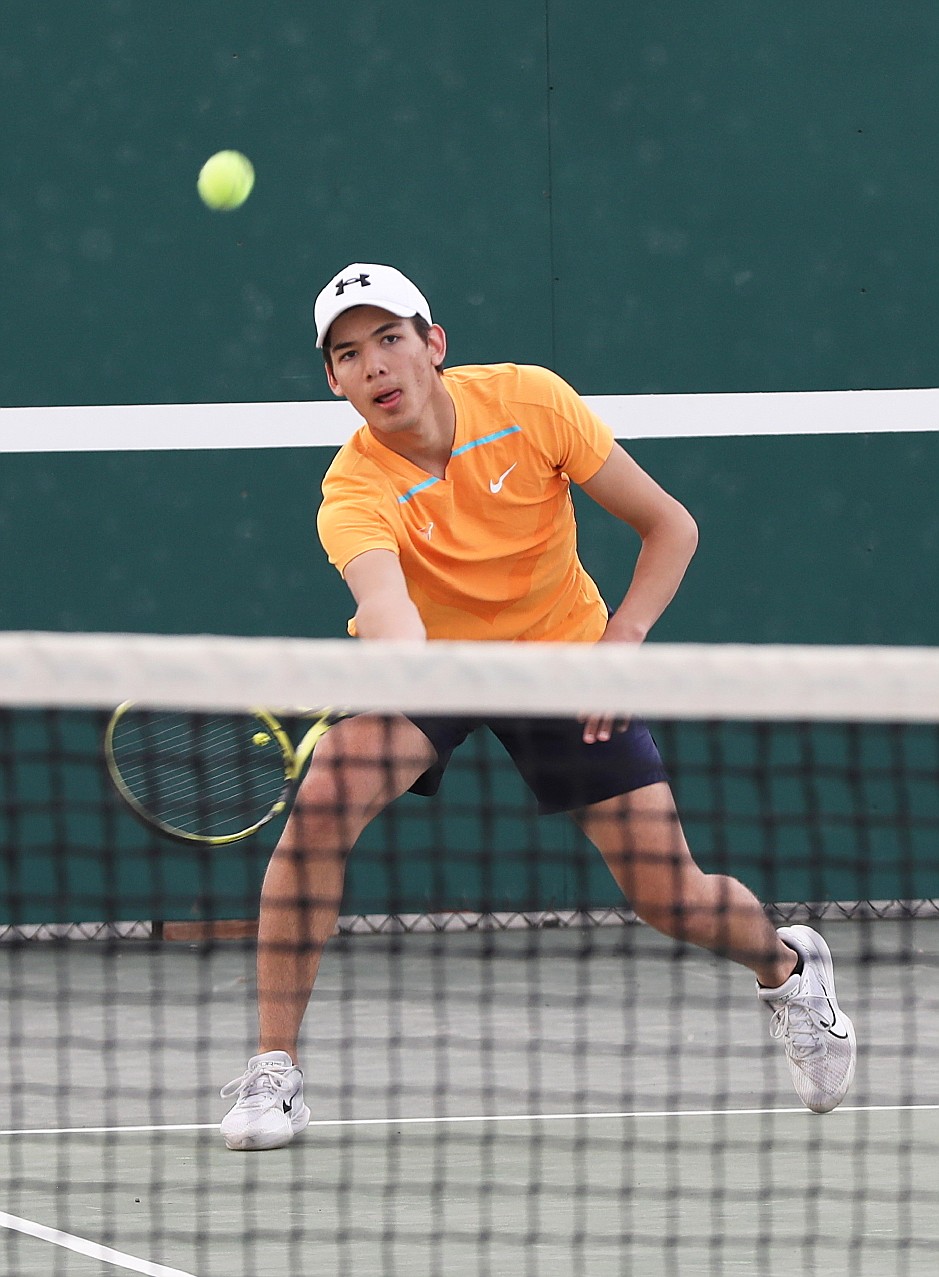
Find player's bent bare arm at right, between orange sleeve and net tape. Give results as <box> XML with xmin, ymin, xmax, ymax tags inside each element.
<box><xmin>581</xmin><ymin>443</ymin><xmax>698</xmax><ymax>642</ymax></box>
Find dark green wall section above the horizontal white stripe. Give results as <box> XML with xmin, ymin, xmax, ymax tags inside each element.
<box><xmin>0</xmin><ymin>0</ymin><xmax>939</xmax><ymax>405</ymax></box>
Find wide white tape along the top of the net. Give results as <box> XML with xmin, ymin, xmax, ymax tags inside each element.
<box><xmin>0</xmin><ymin>632</ymin><xmax>939</xmax><ymax>723</ymax></box>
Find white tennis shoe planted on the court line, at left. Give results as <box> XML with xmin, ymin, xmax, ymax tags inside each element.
<box><xmin>218</xmin><ymin>1051</ymin><xmax>309</xmax><ymax>1152</ymax></box>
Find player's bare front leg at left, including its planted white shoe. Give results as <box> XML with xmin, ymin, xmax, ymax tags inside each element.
<box><xmin>221</xmin><ymin>715</ymin><xmax>437</xmax><ymax>1151</ymax></box>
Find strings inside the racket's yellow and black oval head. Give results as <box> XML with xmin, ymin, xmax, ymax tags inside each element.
<box><xmin>112</xmin><ymin>711</ymin><xmax>286</xmax><ymax>836</ymax></box>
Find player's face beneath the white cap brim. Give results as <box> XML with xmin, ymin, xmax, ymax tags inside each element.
<box><xmin>326</xmin><ymin>306</ymin><xmax>446</xmax><ymax>433</ymax></box>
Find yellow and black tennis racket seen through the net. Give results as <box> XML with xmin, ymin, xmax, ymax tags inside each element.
<box><xmin>105</xmin><ymin>701</ymin><xmax>345</xmax><ymax>847</ymax></box>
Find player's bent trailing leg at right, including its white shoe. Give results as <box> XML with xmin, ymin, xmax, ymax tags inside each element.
<box><xmin>575</xmin><ymin>782</ymin><xmax>857</xmax><ymax>1112</ymax></box>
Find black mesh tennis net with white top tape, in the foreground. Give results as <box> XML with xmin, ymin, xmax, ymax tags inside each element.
<box><xmin>0</xmin><ymin>633</ymin><xmax>939</xmax><ymax>1277</ymax></box>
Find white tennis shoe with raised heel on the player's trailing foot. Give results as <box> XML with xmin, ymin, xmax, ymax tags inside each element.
<box><xmin>758</xmin><ymin>926</ymin><xmax>857</xmax><ymax>1114</ymax></box>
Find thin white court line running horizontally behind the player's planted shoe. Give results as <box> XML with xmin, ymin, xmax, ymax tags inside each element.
<box><xmin>0</xmin><ymin>1105</ymin><xmax>939</xmax><ymax>1138</ymax></box>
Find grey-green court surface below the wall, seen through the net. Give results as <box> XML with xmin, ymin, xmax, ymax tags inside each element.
<box><xmin>0</xmin><ymin>919</ymin><xmax>939</xmax><ymax>1277</ymax></box>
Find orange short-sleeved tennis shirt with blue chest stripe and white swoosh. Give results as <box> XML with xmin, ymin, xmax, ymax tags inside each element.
<box><xmin>317</xmin><ymin>364</ymin><xmax>613</xmax><ymax>642</ymax></box>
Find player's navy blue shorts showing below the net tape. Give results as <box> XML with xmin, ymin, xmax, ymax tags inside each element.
<box><xmin>409</xmin><ymin>715</ymin><xmax>668</xmax><ymax>815</ymax></box>
